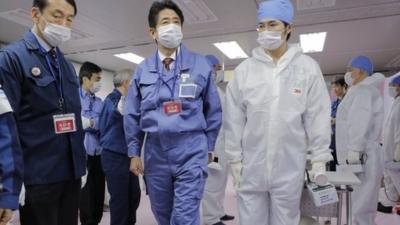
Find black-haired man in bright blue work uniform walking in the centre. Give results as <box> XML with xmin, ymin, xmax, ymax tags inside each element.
<box><xmin>124</xmin><ymin>1</ymin><xmax>221</xmax><ymax>225</ymax></box>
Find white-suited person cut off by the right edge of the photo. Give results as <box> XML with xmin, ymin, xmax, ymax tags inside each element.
<box><xmin>378</xmin><ymin>75</ymin><xmax>400</xmax><ymax>213</ymax></box>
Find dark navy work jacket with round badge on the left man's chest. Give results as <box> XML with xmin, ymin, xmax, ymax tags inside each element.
<box><xmin>0</xmin><ymin>32</ymin><xmax>86</xmax><ymax>185</ymax></box>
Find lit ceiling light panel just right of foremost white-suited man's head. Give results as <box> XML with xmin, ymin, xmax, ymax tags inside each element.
<box><xmin>300</xmin><ymin>32</ymin><xmax>326</xmax><ymax>53</ymax></box>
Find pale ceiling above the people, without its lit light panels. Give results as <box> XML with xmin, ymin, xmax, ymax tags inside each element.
<box><xmin>0</xmin><ymin>0</ymin><xmax>400</xmax><ymax>74</ymax></box>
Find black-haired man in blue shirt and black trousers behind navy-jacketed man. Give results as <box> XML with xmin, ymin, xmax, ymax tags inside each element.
<box><xmin>79</xmin><ymin>62</ymin><xmax>105</xmax><ymax>225</ymax></box>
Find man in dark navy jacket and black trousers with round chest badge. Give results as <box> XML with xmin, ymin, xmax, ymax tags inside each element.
<box><xmin>0</xmin><ymin>0</ymin><xmax>85</xmax><ymax>225</ymax></box>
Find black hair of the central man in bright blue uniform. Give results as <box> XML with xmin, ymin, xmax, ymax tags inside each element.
<box><xmin>148</xmin><ymin>0</ymin><xmax>185</xmax><ymax>28</ymax></box>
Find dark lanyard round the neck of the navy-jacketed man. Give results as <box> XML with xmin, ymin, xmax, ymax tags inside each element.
<box><xmin>35</xmin><ymin>34</ymin><xmax>64</xmax><ymax>109</ymax></box>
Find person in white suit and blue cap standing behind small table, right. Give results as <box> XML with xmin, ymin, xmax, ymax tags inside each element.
<box><xmin>336</xmin><ymin>56</ymin><xmax>384</xmax><ymax>225</ymax></box>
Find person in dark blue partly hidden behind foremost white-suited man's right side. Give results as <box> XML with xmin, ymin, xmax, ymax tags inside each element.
<box><xmin>329</xmin><ymin>77</ymin><xmax>347</xmax><ymax>171</ymax></box>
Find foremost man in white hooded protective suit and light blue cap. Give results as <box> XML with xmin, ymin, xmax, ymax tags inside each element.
<box><xmin>224</xmin><ymin>0</ymin><xmax>332</xmax><ymax>225</ymax></box>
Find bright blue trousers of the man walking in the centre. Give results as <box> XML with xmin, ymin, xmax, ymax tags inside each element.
<box><xmin>144</xmin><ymin>133</ymin><xmax>208</xmax><ymax>225</ymax></box>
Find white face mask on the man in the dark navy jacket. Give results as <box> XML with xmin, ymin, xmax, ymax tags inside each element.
<box><xmin>43</xmin><ymin>21</ymin><xmax>71</xmax><ymax>47</ymax></box>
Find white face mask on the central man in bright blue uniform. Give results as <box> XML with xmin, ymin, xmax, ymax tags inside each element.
<box><xmin>157</xmin><ymin>23</ymin><xmax>183</xmax><ymax>48</ymax></box>
